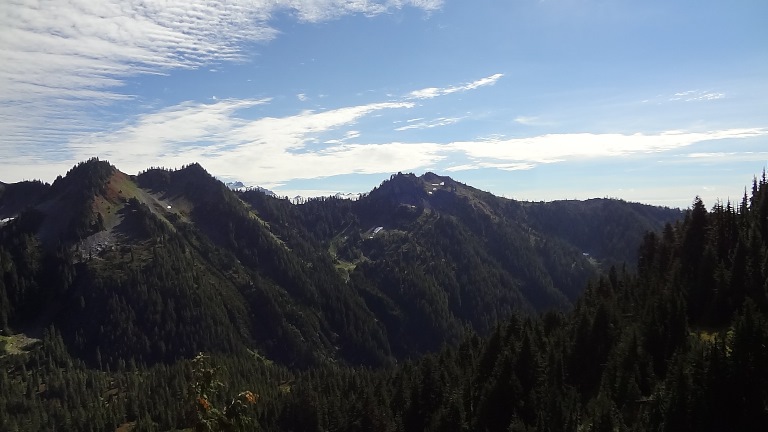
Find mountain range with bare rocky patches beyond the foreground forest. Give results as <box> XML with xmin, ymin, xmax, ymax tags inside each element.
<box><xmin>0</xmin><ymin>159</ymin><xmax>682</xmax><ymax>366</ymax></box>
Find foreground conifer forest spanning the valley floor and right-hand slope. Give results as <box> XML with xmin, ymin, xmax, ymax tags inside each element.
<box><xmin>0</xmin><ymin>170</ymin><xmax>768</xmax><ymax>431</ymax></box>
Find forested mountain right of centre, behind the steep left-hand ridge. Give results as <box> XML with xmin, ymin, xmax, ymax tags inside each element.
<box><xmin>240</xmin><ymin>173</ymin><xmax>680</xmax><ymax>353</ymax></box>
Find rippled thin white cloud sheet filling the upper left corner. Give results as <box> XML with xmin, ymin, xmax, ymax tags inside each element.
<box><xmin>0</xmin><ymin>0</ymin><xmax>442</xmax><ymax>152</ymax></box>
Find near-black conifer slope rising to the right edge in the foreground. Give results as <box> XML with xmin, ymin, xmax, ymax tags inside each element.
<box><xmin>268</xmin><ymin>175</ymin><xmax>768</xmax><ymax>431</ymax></box>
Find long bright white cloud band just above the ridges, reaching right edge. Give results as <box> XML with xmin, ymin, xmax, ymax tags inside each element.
<box><xmin>0</xmin><ymin>85</ymin><xmax>768</xmax><ymax>190</ymax></box>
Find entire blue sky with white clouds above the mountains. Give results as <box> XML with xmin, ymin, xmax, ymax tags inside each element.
<box><xmin>0</xmin><ymin>0</ymin><xmax>768</xmax><ymax>207</ymax></box>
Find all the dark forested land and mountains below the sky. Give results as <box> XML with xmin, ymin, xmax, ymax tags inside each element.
<box><xmin>0</xmin><ymin>160</ymin><xmax>768</xmax><ymax>432</ymax></box>
